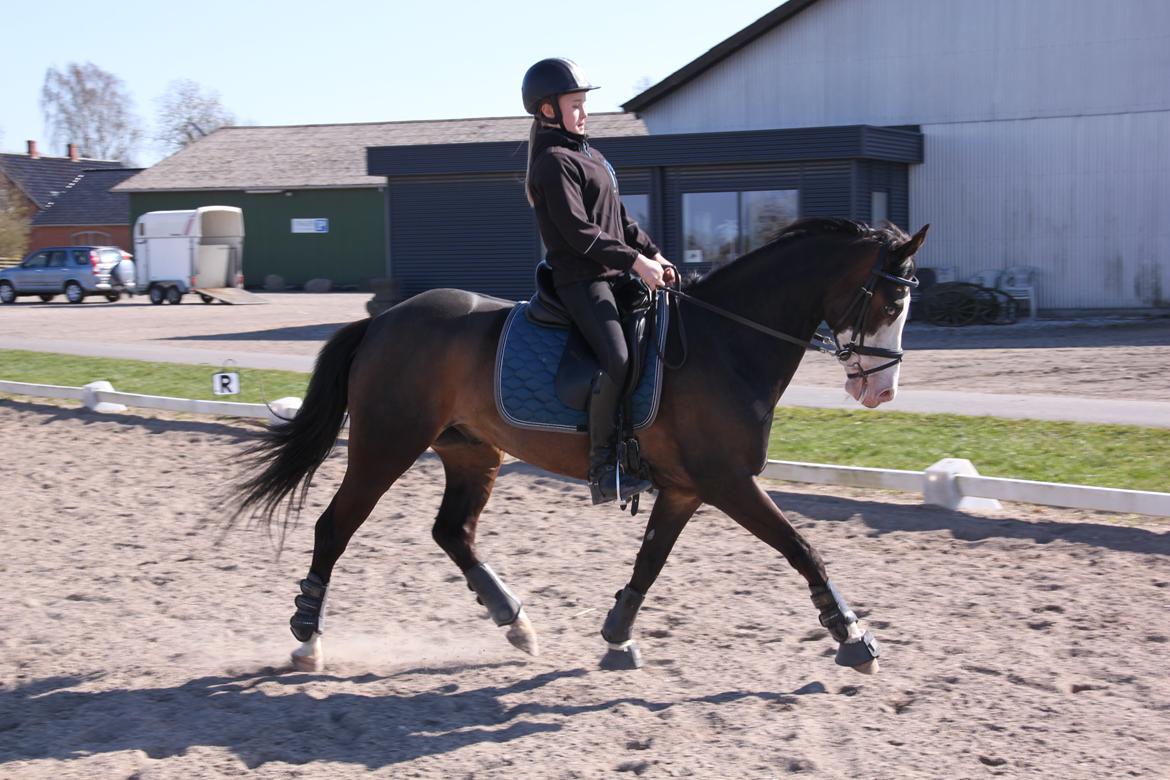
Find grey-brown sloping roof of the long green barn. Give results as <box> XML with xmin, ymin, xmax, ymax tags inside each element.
<box><xmin>115</xmin><ymin>112</ymin><xmax>646</xmax><ymax>192</ymax></box>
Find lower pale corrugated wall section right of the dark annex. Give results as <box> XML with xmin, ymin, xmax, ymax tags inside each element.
<box><xmin>910</xmin><ymin>111</ymin><xmax>1170</xmax><ymax>309</ymax></box>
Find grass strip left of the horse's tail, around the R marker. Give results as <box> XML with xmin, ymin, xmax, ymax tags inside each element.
<box><xmin>0</xmin><ymin>350</ymin><xmax>309</xmax><ymax>403</ymax></box>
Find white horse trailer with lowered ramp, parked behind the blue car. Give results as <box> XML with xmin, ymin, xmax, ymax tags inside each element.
<box><xmin>135</xmin><ymin>206</ymin><xmax>264</xmax><ymax>304</ymax></box>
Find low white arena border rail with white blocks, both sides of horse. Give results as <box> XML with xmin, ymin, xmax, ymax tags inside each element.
<box><xmin>0</xmin><ymin>380</ymin><xmax>1170</xmax><ymax>517</ymax></box>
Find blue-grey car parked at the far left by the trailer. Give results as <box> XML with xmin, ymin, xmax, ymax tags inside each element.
<box><xmin>0</xmin><ymin>247</ymin><xmax>136</xmax><ymax>303</ymax></box>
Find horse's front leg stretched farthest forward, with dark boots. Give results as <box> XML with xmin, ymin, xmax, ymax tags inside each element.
<box><xmin>703</xmin><ymin>478</ymin><xmax>880</xmax><ymax>675</ymax></box>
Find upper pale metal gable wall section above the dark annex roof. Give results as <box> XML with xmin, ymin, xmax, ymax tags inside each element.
<box><xmin>641</xmin><ymin>0</ymin><xmax>1170</xmax><ymax>134</ymax></box>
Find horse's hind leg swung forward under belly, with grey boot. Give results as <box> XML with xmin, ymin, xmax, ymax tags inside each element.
<box><xmin>431</xmin><ymin>429</ymin><xmax>539</xmax><ymax>655</ymax></box>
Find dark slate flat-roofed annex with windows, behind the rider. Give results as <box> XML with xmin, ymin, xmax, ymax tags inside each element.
<box><xmin>369</xmin><ymin>123</ymin><xmax>922</xmax><ymax>298</ymax></box>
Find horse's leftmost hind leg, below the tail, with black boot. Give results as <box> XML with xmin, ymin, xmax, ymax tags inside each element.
<box><xmin>289</xmin><ymin>426</ymin><xmax>434</xmax><ymax>671</ymax></box>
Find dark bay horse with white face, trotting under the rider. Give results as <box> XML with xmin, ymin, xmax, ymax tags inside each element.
<box><xmin>232</xmin><ymin>219</ymin><xmax>929</xmax><ymax>674</ymax></box>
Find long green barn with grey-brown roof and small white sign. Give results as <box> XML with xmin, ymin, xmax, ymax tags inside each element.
<box><xmin>113</xmin><ymin>119</ymin><xmax>646</xmax><ymax>288</ymax></box>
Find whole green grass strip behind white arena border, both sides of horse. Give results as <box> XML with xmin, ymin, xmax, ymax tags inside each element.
<box><xmin>0</xmin><ymin>350</ymin><xmax>1170</xmax><ymax>491</ymax></box>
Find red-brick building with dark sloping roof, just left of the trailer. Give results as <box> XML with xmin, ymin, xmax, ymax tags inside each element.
<box><xmin>29</xmin><ymin>168</ymin><xmax>142</xmax><ymax>251</ymax></box>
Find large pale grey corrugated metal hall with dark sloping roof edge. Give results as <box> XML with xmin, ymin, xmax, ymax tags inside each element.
<box><xmin>622</xmin><ymin>0</ymin><xmax>1170</xmax><ymax>312</ymax></box>
